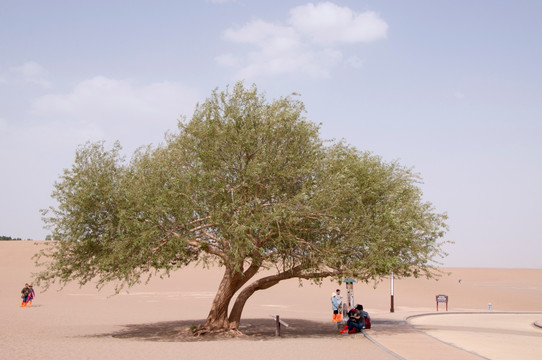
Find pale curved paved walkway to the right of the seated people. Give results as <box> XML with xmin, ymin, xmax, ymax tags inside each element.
<box><xmin>365</xmin><ymin>313</ymin><xmax>542</xmax><ymax>360</ymax></box>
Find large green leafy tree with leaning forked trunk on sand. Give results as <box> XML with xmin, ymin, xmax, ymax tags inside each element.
<box><xmin>36</xmin><ymin>83</ymin><xmax>446</xmax><ymax>333</ymax></box>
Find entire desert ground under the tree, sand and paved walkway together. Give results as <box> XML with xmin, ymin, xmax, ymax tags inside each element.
<box><xmin>0</xmin><ymin>241</ymin><xmax>542</xmax><ymax>360</ymax></box>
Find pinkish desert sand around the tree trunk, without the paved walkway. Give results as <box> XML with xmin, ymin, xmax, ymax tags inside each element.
<box><xmin>0</xmin><ymin>241</ymin><xmax>542</xmax><ymax>360</ymax></box>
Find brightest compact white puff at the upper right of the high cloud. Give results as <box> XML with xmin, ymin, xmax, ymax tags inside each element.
<box><xmin>289</xmin><ymin>2</ymin><xmax>388</xmax><ymax>44</ymax></box>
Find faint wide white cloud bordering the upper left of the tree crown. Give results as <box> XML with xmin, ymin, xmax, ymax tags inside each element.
<box><xmin>30</xmin><ymin>76</ymin><xmax>197</xmax><ymax>150</ymax></box>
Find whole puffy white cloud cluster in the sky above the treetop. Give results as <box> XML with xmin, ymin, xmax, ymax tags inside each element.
<box><xmin>215</xmin><ymin>2</ymin><xmax>387</xmax><ymax>80</ymax></box>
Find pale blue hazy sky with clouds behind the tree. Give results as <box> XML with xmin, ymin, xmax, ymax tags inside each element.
<box><xmin>0</xmin><ymin>0</ymin><xmax>542</xmax><ymax>268</ymax></box>
